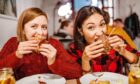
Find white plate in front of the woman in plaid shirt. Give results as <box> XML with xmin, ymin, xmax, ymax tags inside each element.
<box><xmin>80</xmin><ymin>72</ymin><xmax>128</xmax><ymax>84</ymax></box>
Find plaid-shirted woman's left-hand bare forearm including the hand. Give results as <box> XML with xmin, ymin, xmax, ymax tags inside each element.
<box><xmin>82</xmin><ymin>41</ymin><xmax>104</xmax><ymax>74</ymax></box>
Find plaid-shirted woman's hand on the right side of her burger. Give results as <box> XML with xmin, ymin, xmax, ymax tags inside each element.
<box><xmin>109</xmin><ymin>35</ymin><xmax>126</xmax><ymax>54</ymax></box>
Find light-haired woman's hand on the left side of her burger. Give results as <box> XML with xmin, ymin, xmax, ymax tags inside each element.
<box><xmin>16</xmin><ymin>40</ymin><xmax>38</xmax><ymax>58</ymax></box>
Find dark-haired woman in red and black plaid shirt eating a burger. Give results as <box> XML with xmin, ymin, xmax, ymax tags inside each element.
<box><xmin>69</xmin><ymin>6</ymin><xmax>138</xmax><ymax>73</ymax></box>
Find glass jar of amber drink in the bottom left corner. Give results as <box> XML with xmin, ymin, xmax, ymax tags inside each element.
<box><xmin>0</xmin><ymin>68</ymin><xmax>15</xmax><ymax>84</ymax></box>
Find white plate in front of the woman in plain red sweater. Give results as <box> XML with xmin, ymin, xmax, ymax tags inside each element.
<box><xmin>16</xmin><ymin>74</ymin><xmax>66</xmax><ymax>84</ymax></box>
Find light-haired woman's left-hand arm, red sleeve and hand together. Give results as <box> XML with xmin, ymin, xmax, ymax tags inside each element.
<box><xmin>0</xmin><ymin>37</ymin><xmax>36</xmax><ymax>68</ymax></box>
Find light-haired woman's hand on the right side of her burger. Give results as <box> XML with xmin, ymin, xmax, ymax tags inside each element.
<box><xmin>39</xmin><ymin>44</ymin><xmax>57</xmax><ymax>65</ymax></box>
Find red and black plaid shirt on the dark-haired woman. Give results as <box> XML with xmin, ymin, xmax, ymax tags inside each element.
<box><xmin>68</xmin><ymin>43</ymin><xmax>139</xmax><ymax>74</ymax></box>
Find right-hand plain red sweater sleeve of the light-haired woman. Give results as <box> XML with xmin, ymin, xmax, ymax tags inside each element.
<box><xmin>49</xmin><ymin>38</ymin><xmax>82</xmax><ymax>79</ymax></box>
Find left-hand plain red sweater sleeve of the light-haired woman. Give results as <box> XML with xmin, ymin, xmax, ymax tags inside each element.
<box><xmin>0</xmin><ymin>37</ymin><xmax>20</xmax><ymax>68</ymax></box>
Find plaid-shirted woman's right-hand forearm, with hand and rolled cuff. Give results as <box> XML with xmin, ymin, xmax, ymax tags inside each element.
<box><xmin>109</xmin><ymin>36</ymin><xmax>138</xmax><ymax>63</ymax></box>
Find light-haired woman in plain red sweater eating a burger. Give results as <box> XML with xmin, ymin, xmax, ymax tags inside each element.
<box><xmin>0</xmin><ymin>8</ymin><xmax>82</xmax><ymax>80</ymax></box>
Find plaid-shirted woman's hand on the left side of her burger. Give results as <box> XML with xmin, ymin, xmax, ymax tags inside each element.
<box><xmin>82</xmin><ymin>40</ymin><xmax>104</xmax><ymax>61</ymax></box>
